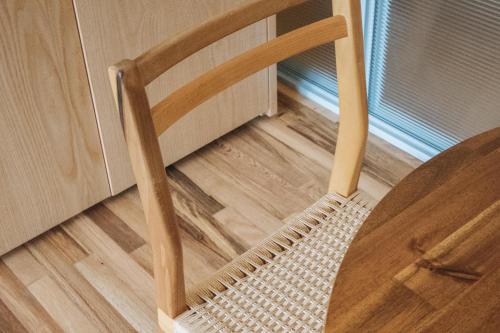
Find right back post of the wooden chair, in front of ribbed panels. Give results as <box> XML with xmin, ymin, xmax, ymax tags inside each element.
<box><xmin>329</xmin><ymin>0</ymin><xmax>368</xmax><ymax>197</ymax></box>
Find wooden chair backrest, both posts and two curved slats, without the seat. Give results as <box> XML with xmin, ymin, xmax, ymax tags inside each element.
<box><xmin>109</xmin><ymin>0</ymin><xmax>368</xmax><ymax>319</ymax></box>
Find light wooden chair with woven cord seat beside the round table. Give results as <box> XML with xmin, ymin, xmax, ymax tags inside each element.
<box><xmin>109</xmin><ymin>0</ymin><xmax>370</xmax><ymax>332</ymax></box>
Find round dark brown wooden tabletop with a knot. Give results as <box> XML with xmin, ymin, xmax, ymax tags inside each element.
<box><xmin>327</xmin><ymin>128</ymin><xmax>500</xmax><ymax>332</ymax></box>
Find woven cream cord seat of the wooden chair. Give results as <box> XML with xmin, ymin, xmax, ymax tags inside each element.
<box><xmin>175</xmin><ymin>192</ymin><xmax>371</xmax><ymax>333</ymax></box>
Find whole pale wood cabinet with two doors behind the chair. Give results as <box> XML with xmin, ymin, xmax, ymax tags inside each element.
<box><xmin>0</xmin><ymin>0</ymin><xmax>276</xmax><ymax>254</ymax></box>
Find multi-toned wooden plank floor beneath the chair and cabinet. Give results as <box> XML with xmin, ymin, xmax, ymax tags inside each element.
<box><xmin>0</xmin><ymin>87</ymin><xmax>420</xmax><ymax>332</ymax></box>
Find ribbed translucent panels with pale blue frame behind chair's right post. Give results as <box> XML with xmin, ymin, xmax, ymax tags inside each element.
<box><xmin>278</xmin><ymin>0</ymin><xmax>500</xmax><ymax>154</ymax></box>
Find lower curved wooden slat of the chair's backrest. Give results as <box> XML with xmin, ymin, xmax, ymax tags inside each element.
<box><xmin>152</xmin><ymin>16</ymin><xmax>347</xmax><ymax>136</ymax></box>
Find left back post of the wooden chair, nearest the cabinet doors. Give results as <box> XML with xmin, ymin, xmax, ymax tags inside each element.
<box><xmin>109</xmin><ymin>60</ymin><xmax>187</xmax><ymax>324</ymax></box>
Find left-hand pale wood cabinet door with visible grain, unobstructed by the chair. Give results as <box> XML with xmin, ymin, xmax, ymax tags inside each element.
<box><xmin>0</xmin><ymin>0</ymin><xmax>109</xmax><ymax>254</ymax></box>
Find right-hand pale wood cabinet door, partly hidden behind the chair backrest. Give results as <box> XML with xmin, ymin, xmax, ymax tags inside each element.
<box><xmin>75</xmin><ymin>0</ymin><xmax>275</xmax><ymax>194</ymax></box>
